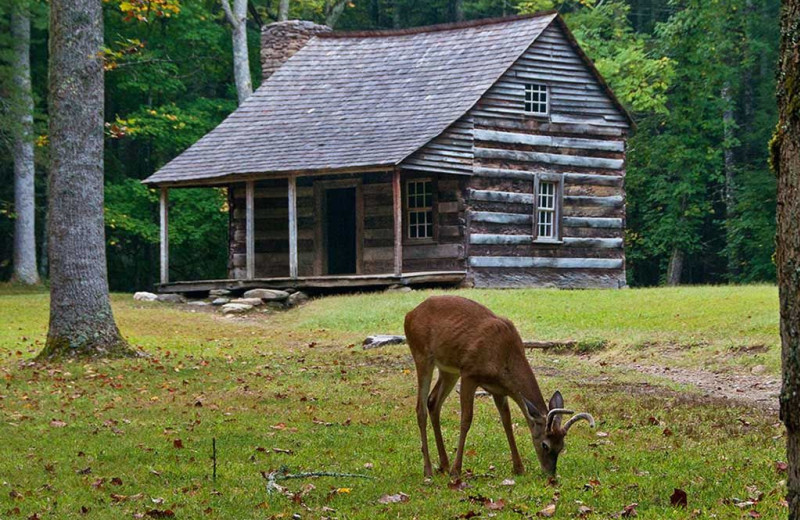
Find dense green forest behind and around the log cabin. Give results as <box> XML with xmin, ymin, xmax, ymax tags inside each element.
<box><xmin>0</xmin><ymin>0</ymin><xmax>780</xmax><ymax>291</ymax></box>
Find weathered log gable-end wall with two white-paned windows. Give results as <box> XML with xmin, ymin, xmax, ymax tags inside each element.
<box><xmin>467</xmin><ymin>25</ymin><xmax>628</xmax><ymax>288</ymax></box>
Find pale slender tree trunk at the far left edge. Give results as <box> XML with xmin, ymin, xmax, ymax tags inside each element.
<box><xmin>11</xmin><ymin>2</ymin><xmax>39</xmax><ymax>284</ymax></box>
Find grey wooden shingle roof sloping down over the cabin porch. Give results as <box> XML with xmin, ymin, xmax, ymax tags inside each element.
<box><xmin>144</xmin><ymin>13</ymin><xmax>557</xmax><ymax>184</ymax></box>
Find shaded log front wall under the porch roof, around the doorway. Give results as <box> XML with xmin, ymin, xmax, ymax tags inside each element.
<box><xmin>229</xmin><ymin>172</ymin><xmax>468</xmax><ymax>279</ymax></box>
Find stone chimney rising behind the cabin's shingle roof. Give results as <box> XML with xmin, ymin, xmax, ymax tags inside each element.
<box><xmin>261</xmin><ymin>20</ymin><xmax>331</xmax><ymax>81</ymax></box>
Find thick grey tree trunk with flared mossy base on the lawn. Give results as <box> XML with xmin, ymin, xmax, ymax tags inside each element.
<box><xmin>39</xmin><ymin>0</ymin><xmax>131</xmax><ymax>359</ymax></box>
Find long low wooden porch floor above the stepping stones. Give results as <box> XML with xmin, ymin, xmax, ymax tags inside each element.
<box><xmin>156</xmin><ymin>271</ymin><xmax>467</xmax><ymax>293</ymax></box>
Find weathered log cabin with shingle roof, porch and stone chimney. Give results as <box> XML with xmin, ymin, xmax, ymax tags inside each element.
<box><xmin>144</xmin><ymin>12</ymin><xmax>633</xmax><ymax>292</ymax></box>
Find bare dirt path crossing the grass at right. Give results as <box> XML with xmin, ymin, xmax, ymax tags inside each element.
<box><xmin>617</xmin><ymin>364</ymin><xmax>781</xmax><ymax>415</ymax></box>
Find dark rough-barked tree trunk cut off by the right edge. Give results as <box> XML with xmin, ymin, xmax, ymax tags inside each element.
<box><xmin>771</xmin><ymin>0</ymin><xmax>800</xmax><ymax>520</ymax></box>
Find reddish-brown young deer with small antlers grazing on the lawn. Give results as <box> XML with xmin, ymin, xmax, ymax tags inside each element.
<box><xmin>405</xmin><ymin>296</ymin><xmax>594</xmax><ymax>477</ymax></box>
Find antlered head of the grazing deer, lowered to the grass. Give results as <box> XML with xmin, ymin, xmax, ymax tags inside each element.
<box><xmin>523</xmin><ymin>390</ymin><xmax>594</xmax><ymax>475</ymax></box>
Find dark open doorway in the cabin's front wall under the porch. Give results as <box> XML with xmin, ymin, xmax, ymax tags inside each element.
<box><xmin>325</xmin><ymin>188</ymin><xmax>356</xmax><ymax>274</ymax></box>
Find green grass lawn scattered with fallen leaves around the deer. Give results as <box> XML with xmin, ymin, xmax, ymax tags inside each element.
<box><xmin>0</xmin><ymin>286</ymin><xmax>786</xmax><ymax>519</ymax></box>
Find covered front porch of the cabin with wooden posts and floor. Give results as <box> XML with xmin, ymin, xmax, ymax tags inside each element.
<box><xmin>156</xmin><ymin>168</ymin><xmax>467</xmax><ymax>293</ymax></box>
